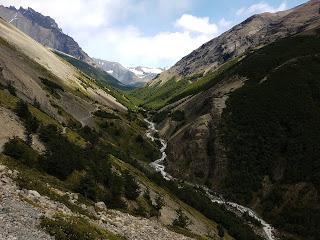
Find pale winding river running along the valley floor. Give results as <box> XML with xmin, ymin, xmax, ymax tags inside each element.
<box><xmin>144</xmin><ymin>119</ymin><xmax>277</xmax><ymax>240</ymax></box>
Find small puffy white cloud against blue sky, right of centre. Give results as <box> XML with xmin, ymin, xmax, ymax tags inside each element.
<box><xmin>175</xmin><ymin>14</ymin><xmax>218</xmax><ymax>34</ymax></box>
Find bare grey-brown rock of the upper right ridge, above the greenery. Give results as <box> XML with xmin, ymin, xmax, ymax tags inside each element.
<box><xmin>150</xmin><ymin>0</ymin><xmax>320</xmax><ymax>86</ymax></box>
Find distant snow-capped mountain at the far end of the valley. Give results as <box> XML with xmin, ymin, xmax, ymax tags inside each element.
<box><xmin>95</xmin><ymin>59</ymin><xmax>163</xmax><ymax>86</ymax></box>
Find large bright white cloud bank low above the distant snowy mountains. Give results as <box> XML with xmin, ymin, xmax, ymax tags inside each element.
<box><xmin>85</xmin><ymin>24</ymin><xmax>216</xmax><ymax>66</ymax></box>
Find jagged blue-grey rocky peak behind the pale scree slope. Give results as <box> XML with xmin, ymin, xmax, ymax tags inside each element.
<box><xmin>0</xmin><ymin>6</ymin><xmax>93</xmax><ymax>63</ymax></box>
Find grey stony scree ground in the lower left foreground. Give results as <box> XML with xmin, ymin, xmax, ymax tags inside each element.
<box><xmin>0</xmin><ymin>165</ymin><xmax>190</xmax><ymax>240</ymax></box>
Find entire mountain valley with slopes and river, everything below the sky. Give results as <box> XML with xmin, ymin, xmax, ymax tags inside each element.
<box><xmin>0</xmin><ymin>0</ymin><xmax>320</xmax><ymax>240</ymax></box>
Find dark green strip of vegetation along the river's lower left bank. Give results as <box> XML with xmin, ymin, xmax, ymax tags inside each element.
<box><xmin>112</xmin><ymin>158</ymin><xmax>262</xmax><ymax>240</ymax></box>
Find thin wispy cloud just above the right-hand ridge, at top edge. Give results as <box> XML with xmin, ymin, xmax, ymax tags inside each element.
<box><xmin>236</xmin><ymin>1</ymin><xmax>287</xmax><ymax>17</ymax></box>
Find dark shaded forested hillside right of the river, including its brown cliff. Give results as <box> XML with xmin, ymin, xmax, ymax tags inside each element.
<box><xmin>154</xmin><ymin>31</ymin><xmax>320</xmax><ymax>239</ymax></box>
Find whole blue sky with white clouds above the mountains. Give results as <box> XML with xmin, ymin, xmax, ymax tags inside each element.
<box><xmin>0</xmin><ymin>0</ymin><xmax>306</xmax><ymax>67</ymax></box>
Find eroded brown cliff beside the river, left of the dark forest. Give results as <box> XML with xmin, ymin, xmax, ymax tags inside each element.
<box><xmin>161</xmin><ymin>77</ymin><xmax>246</xmax><ymax>186</ymax></box>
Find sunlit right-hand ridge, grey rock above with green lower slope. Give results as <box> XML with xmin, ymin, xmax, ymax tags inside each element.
<box><xmin>132</xmin><ymin>0</ymin><xmax>320</xmax><ymax>108</ymax></box>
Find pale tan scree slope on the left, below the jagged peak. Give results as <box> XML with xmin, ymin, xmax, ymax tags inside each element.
<box><xmin>0</xmin><ymin>16</ymin><xmax>126</xmax><ymax>122</ymax></box>
